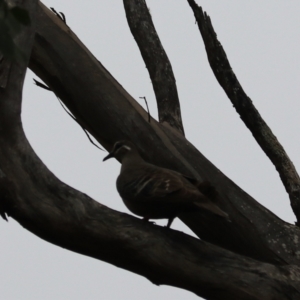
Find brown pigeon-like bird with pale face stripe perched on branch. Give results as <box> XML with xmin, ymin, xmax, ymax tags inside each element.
<box><xmin>103</xmin><ymin>140</ymin><xmax>228</xmax><ymax>228</ymax></box>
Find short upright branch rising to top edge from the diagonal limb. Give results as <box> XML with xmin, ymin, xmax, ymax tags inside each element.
<box><xmin>123</xmin><ymin>0</ymin><xmax>184</xmax><ymax>134</ymax></box>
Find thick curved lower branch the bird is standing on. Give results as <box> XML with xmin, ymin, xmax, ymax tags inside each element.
<box><xmin>0</xmin><ymin>29</ymin><xmax>300</xmax><ymax>300</ymax></box>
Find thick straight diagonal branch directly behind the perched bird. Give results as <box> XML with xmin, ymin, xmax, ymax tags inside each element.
<box><xmin>30</xmin><ymin>4</ymin><xmax>300</xmax><ymax>264</ymax></box>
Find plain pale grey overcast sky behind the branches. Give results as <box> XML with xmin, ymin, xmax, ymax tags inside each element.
<box><xmin>0</xmin><ymin>0</ymin><xmax>300</xmax><ymax>300</ymax></box>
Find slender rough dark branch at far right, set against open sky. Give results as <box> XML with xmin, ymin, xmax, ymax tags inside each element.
<box><xmin>188</xmin><ymin>0</ymin><xmax>300</xmax><ymax>225</ymax></box>
